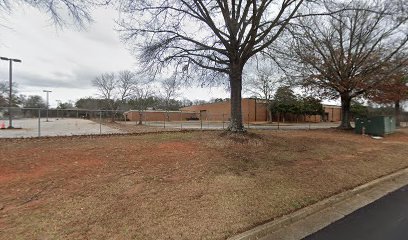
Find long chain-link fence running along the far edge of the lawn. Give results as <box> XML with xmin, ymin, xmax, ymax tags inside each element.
<box><xmin>0</xmin><ymin>107</ymin><xmax>408</xmax><ymax>138</ymax></box>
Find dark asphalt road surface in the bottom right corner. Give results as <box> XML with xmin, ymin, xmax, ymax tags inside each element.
<box><xmin>303</xmin><ymin>185</ymin><xmax>408</xmax><ymax>240</ymax></box>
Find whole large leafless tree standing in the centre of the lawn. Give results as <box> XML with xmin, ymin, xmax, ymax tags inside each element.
<box><xmin>116</xmin><ymin>0</ymin><xmax>326</xmax><ymax>132</ymax></box>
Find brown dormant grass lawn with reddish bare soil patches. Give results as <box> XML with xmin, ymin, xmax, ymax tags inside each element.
<box><xmin>0</xmin><ymin>129</ymin><xmax>408</xmax><ymax>239</ymax></box>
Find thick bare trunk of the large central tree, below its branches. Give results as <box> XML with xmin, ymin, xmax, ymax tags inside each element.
<box><xmin>227</xmin><ymin>63</ymin><xmax>245</xmax><ymax>132</ymax></box>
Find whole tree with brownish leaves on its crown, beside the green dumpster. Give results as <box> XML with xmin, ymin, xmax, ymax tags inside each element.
<box><xmin>275</xmin><ymin>1</ymin><xmax>408</xmax><ymax>129</ymax></box>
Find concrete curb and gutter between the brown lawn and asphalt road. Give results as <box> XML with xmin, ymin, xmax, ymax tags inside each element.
<box><xmin>228</xmin><ymin>168</ymin><xmax>408</xmax><ymax>240</ymax></box>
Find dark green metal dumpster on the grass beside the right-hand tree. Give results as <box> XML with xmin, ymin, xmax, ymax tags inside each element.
<box><xmin>354</xmin><ymin>116</ymin><xmax>396</xmax><ymax>136</ymax></box>
